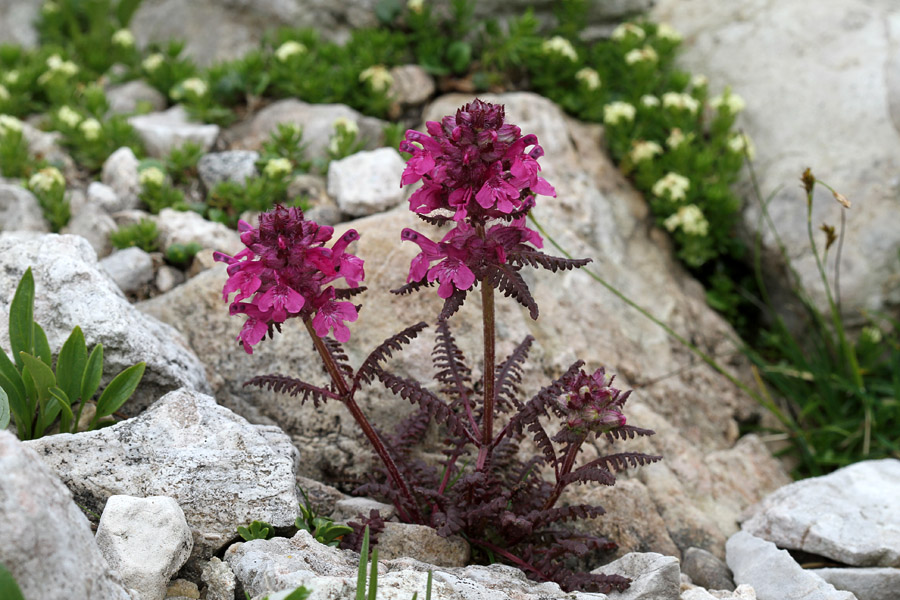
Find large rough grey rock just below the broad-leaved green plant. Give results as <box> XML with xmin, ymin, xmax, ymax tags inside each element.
<box><xmin>28</xmin><ymin>389</ymin><xmax>298</xmax><ymax>559</ymax></box>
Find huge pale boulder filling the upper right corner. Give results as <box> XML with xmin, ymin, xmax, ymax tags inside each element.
<box><xmin>652</xmin><ymin>0</ymin><xmax>900</xmax><ymax>319</ymax></box>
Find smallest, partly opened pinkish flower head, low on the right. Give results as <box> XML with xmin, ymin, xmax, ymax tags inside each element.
<box><xmin>559</xmin><ymin>367</ymin><xmax>631</xmax><ymax>434</ymax></box>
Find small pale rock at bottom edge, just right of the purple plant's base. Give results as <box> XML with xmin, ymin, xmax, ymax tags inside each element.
<box><xmin>591</xmin><ymin>552</ymin><xmax>681</xmax><ymax>600</ymax></box>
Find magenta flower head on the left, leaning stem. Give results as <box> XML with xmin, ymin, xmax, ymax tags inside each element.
<box><xmin>213</xmin><ymin>206</ymin><xmax>364</xmax><ymax>354</ymax></box>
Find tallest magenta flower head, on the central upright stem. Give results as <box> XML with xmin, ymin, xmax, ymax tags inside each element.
<box><xmin>400</xmin><ymin>99</ymin><xmax>556</xmax><ymax>298</ymax></box>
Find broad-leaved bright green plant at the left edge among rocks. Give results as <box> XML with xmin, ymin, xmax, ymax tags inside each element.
<box><xmin>0</xmin><ymin>268</ymin><xmax>145</xmax><ymax>440</ymax></box>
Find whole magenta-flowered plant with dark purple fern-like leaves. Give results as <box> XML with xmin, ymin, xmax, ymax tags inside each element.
<box><xmin>216</xmin><ymin>100</ymin><xmax>661</xmax><ymax>591</ymax></box>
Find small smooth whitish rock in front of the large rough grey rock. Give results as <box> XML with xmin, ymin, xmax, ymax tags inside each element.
<box><xmin>96</xmin><ymin>496</ymin><xmax>194</xmax><ymax>600</ymax></box>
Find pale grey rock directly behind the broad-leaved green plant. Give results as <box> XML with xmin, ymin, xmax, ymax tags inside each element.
<box><xmin>0</xmin><ymin>233</ymin><xmax>210</xmax><ymax>415</ymax></box>
